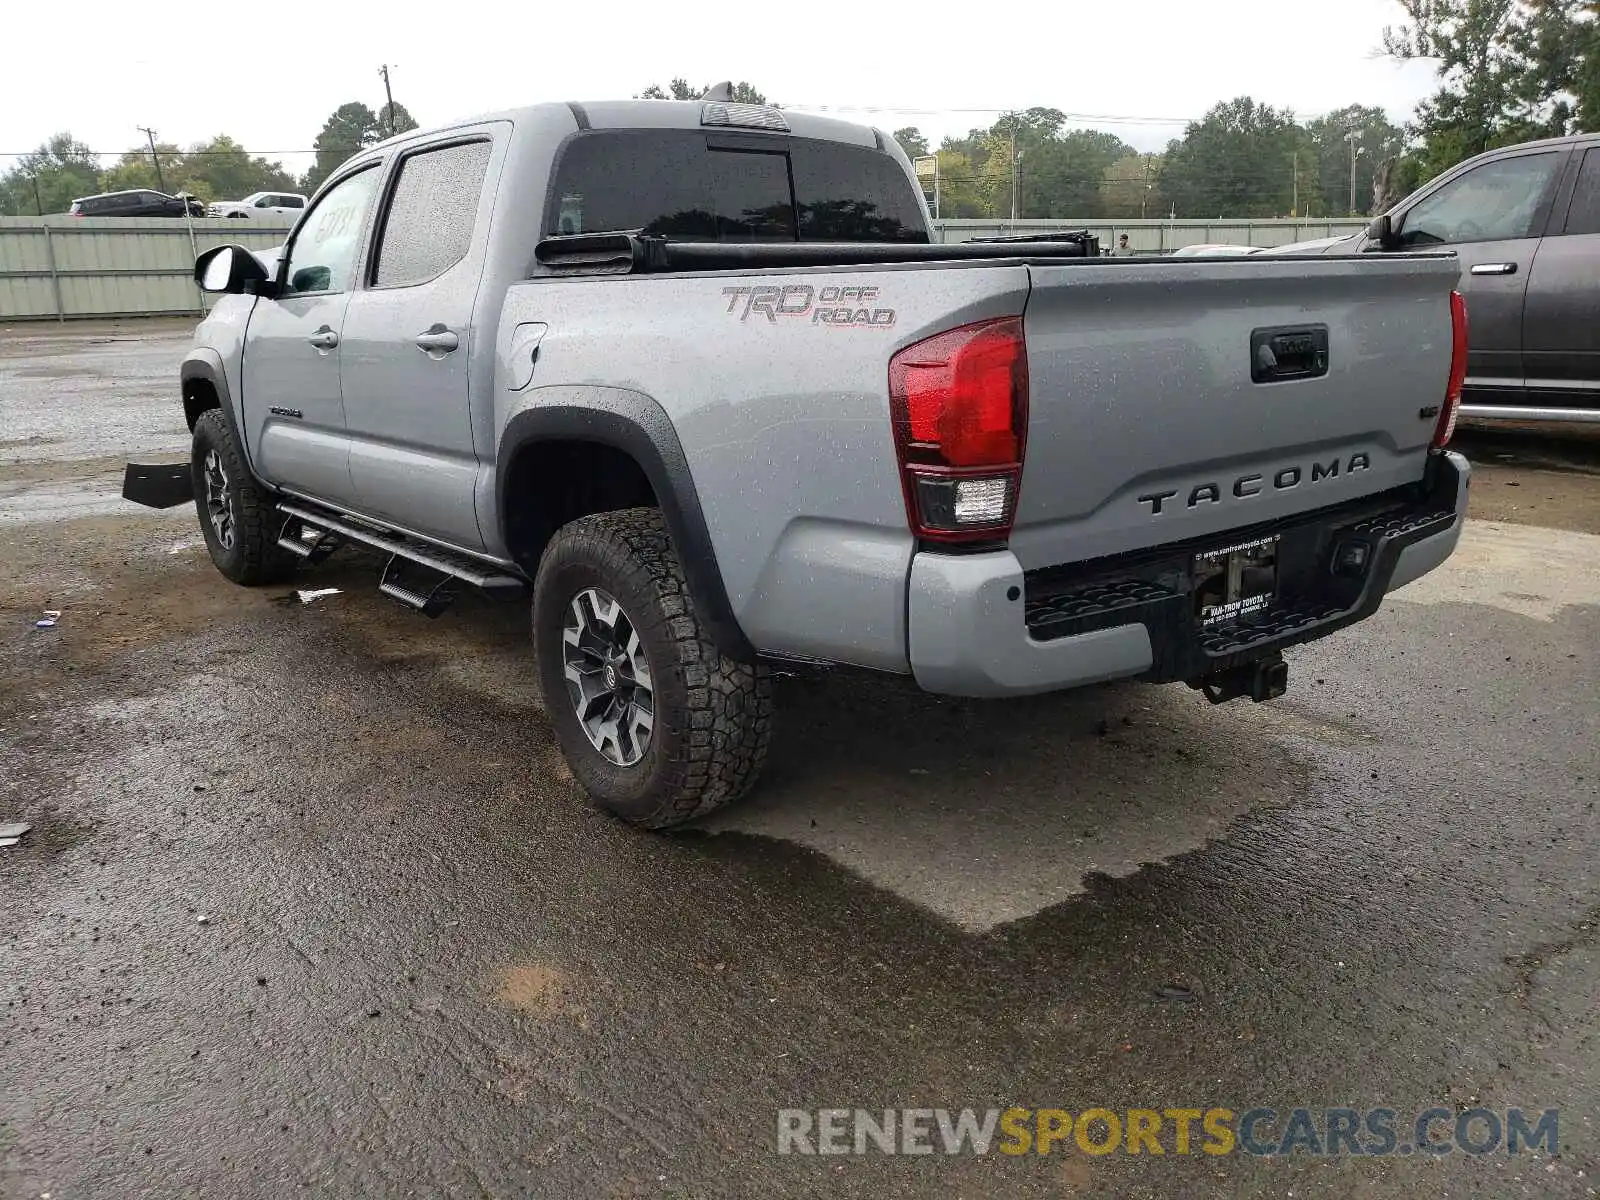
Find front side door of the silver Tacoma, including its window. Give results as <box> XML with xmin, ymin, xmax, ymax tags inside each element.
<box><xmin>242</xmin><ymin>163</ymin><xmax>381</xmax><ymax>504</ymax></box>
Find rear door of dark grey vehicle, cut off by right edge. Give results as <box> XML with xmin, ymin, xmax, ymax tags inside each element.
<box><xmin>1522</xmin><ymin>146</ymin><xmax>1600</xmax><ymax>408</ymax></box>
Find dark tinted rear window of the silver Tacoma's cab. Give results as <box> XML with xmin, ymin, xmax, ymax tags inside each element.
<box><xmin>544</xmin><ymin>130</ymin><xmax>928</xmax><ymax>242</ymax></box>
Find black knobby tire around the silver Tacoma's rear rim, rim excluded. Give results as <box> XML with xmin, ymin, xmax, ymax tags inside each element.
<box><xmin>533</xmin><ymin>509</ymin><xmax>773</xmax><ymax>829</ymax></box>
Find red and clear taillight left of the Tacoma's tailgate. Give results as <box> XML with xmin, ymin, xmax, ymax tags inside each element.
<box><xmin>890</xmin><ymin>317</ymin><xmax>1027</xmax><ymax>541</ymax></box>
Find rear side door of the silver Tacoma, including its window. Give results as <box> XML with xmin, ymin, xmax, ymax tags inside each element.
<box><xmin>341</xmin><ymin>131</ymin><xmax>499</xmax><ymax>549</ymax></box>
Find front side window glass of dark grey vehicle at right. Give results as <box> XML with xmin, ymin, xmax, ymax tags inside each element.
<box><xmin>1400</xmin><ymin>150</ymin><xmax>1562</xmax><ymax>246</ymax></box>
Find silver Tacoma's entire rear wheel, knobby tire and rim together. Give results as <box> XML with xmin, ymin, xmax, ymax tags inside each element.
<box><xmin>533</xmin><ymin>509</ymin><xmax>773</xmax><ymax>829</ymax></box>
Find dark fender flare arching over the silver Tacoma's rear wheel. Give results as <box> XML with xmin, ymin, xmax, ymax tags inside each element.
<box><xmin>494</xmin><ymin>387</ymin><xmax>755</xmax><ymax>662</ymax></box>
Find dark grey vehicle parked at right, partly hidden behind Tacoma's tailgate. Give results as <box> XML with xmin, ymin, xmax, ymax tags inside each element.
<box><xmin>1272</xmin><ymin>133</ymin><xmax>1600</xmax><ymax>421</ymax></box>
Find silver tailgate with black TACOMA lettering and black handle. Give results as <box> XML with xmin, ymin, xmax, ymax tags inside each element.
<box><xmin>1011</xmin><ymin>254</ymin><xmax>1459</xmax><ymax>570</ymax></box>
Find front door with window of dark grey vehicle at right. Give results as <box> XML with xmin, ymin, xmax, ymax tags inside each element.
<box><xmin>1397</xmin><ymin>150</ymin><xmax>1566</xmax><ymax>389</ymax></box>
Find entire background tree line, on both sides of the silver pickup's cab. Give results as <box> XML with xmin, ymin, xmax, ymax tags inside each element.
<box><xmin>9</xmin><ymin>0</ymin><xmax>1600</xmax><ymax>219</ymax></box>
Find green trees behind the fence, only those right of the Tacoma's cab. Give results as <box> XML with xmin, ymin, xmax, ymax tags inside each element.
<box><xmin>894</xmin><ymin>0</ymin><xmax>1600</xmax><ymax>219</ymax></box>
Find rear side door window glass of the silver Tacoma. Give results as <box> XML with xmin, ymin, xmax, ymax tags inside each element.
<box><xmin>373</xmin><ymin>142</ymin><xmax>490</xmax><ymax>288</ymax></box>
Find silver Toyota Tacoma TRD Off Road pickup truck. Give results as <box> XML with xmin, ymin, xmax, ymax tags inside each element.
<box><xmin>125</xmin><ymin>101</ymin><xmax>1469</xmax><ymax>827</ymax></box>
